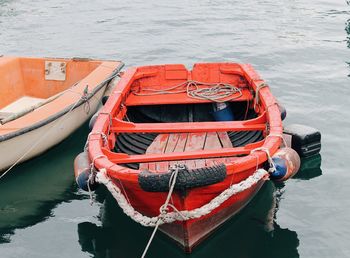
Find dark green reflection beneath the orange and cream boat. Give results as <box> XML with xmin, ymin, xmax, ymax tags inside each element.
<box><xmin>0</xmin><ymin>123</ymin><xmax>88</xmax><ymax>243</ymax></box>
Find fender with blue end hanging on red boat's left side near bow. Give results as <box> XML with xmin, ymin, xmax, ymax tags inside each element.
<box><xmin>74</xmin><ymin>151</ymin><xmax>99</xmax><ymax>191</ymax></box>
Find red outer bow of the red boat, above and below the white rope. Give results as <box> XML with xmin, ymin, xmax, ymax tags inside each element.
<box><xmin>108</xmin><ymin>170</ymin><xmax>265</xmax><ymax>253</ymax></box>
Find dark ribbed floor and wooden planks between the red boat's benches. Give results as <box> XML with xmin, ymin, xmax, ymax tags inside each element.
<box><xmin>114</xmin><ymin>102</ymin><xmax>263</xmax><ymax>172</ymax></box>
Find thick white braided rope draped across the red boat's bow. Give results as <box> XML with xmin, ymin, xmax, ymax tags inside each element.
<box><xmin>96</xmin><ymin>169</ymin><xmax>269</xmax><ymax>227</ymax></box>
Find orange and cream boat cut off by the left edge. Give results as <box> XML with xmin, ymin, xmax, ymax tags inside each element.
<box><xmin>0</xmin><ymin>57</ymin><xmax>123</xmax><ymax>171</ymax></box>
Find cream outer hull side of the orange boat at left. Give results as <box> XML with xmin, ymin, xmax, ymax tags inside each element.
<box><xmin>0</xmin><ymin>87</ymin><xmax>106</xmax><ymax>171</ymax></box>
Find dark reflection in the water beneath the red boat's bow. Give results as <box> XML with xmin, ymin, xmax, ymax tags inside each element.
<box><xmin>78</xmin><ymin>155</ymin><xmax>322</xmax><ymax>258</ymax></box>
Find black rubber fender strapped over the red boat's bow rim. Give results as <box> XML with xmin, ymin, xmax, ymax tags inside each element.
<box><xmin>138</xmin><ymin>164</ymin><xmax>226</xmax><ymax>192</ymax></box>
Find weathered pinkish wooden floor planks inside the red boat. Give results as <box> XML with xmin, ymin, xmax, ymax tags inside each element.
<box><xmin>139</xmin><ymin>132</ymin><xmax>236</xmax><ymax>173</ymax></box>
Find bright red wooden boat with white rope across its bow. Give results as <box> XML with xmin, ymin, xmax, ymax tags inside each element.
<box><xmin>75</xmin><ymin>63</ymin><xmax>298</xmax><ymax>252</ymax></box>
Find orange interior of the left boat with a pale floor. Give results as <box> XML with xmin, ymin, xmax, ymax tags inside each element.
<box><xmin>0</xmin><ymin>57</ymin><xmax>101</xmax><ymax>119</ymax></box>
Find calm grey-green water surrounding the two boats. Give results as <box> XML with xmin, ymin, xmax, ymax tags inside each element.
<box><xmin>0</xmin><ymin>0</ymin><xmax>350</xmax><ymax>258</ymax></box>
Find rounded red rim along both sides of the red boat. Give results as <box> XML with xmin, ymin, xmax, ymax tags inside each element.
<box><xmin>88</xmin><ymin>63</ymin><xmax>282</xmax><ymax>182</ymax></box>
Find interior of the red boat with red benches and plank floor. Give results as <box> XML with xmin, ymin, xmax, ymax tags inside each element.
<box><xmin>106</xmin><ymin>64</ymin><xmax>266</xmax><ymax>173</ymax></box>
